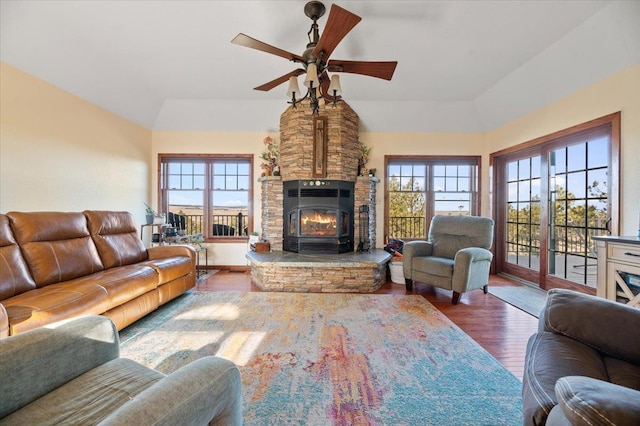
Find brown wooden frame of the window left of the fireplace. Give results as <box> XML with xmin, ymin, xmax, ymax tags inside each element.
<box><xmin>157</xmin><ymin>153</ymin><xmax>255</xmax><ymax>243</ymax></box>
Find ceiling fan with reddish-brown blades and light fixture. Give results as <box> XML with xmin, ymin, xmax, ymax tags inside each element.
<box><xmin>231</xmin><ymin>1</ymin><xmax>398</xmax><ymax>115</ymax></box>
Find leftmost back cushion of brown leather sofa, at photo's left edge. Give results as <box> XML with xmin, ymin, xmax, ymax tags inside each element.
<box><xmin>0</xmin><ymin>214</ymin><xmax>36</xmax><ymax>300</ymax></box>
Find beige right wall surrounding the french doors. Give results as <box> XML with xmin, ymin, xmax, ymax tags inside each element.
<box><xmin>483</xmin><ymin>64</ymin><xmax>640</xmax><ymax>235</ymax></box>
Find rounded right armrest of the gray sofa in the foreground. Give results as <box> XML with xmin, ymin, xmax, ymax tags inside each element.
<box><xmin>100</xmin><ymin>357</ymin><xmax>242</xmax><ymax>426</ymax></box>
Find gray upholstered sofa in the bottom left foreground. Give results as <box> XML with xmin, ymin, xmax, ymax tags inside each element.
<box><xmin>0</xmin><ymin>315</ymin><xmax>242</xmax><ymax>425</ymax></box>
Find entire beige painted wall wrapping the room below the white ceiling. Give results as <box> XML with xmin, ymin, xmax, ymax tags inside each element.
<box><xmin>0</xmin><ymin>63</ymin><xmax>640</xmax><ymax>265</ymax></box>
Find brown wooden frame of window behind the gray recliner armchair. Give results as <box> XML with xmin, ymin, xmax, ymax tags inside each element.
<box><xmin>384</xmin><ymin>155</ymin><xmax>482</xmax><ymax>241</ymax></box>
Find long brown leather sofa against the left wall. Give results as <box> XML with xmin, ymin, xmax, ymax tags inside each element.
<box><xmin>0</xmin><ymin>211</ymin><xmax>195</xmax><ymax>337</ymax></box>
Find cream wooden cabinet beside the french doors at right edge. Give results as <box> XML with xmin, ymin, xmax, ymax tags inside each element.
<box><xmin>593</xmin><ymin>236</ymin><xmax>640</xmax><ymax>308</ymax></box>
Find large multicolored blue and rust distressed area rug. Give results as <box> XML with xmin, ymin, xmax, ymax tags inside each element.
<box><xmin>120</xmin><ymin>292</ymin><xmax>522</xmax><ymax>425</ymax></box>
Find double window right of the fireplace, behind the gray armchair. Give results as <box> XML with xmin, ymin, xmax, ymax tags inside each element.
<box><xmin>385</xmin><ymin>156</ymin><xmax>480</xmax><ymax>240</ymax></box>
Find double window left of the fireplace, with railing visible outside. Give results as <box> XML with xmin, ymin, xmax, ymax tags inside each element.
<box><xmin>158</xmin><ymin>154</ymin><xmax>253</xmax><ymax>241</ymax></box>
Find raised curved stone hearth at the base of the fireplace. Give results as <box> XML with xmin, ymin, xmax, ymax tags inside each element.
<box><xmin>247</xmin><ymin>250</ymin><xmax>391</xmax><ymax>293</ymax></box>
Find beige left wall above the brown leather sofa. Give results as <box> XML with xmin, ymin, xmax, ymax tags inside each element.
<box><xmin>0</xmin><ymin>63</ymin><xmax>153</xmax><ymax>222</ymax></box>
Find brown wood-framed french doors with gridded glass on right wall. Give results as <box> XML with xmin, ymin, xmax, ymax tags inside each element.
<box><xmin>491</xmin><ymin>113</ymin><xmax>620</xmax><ymax>293</ymax></box>
